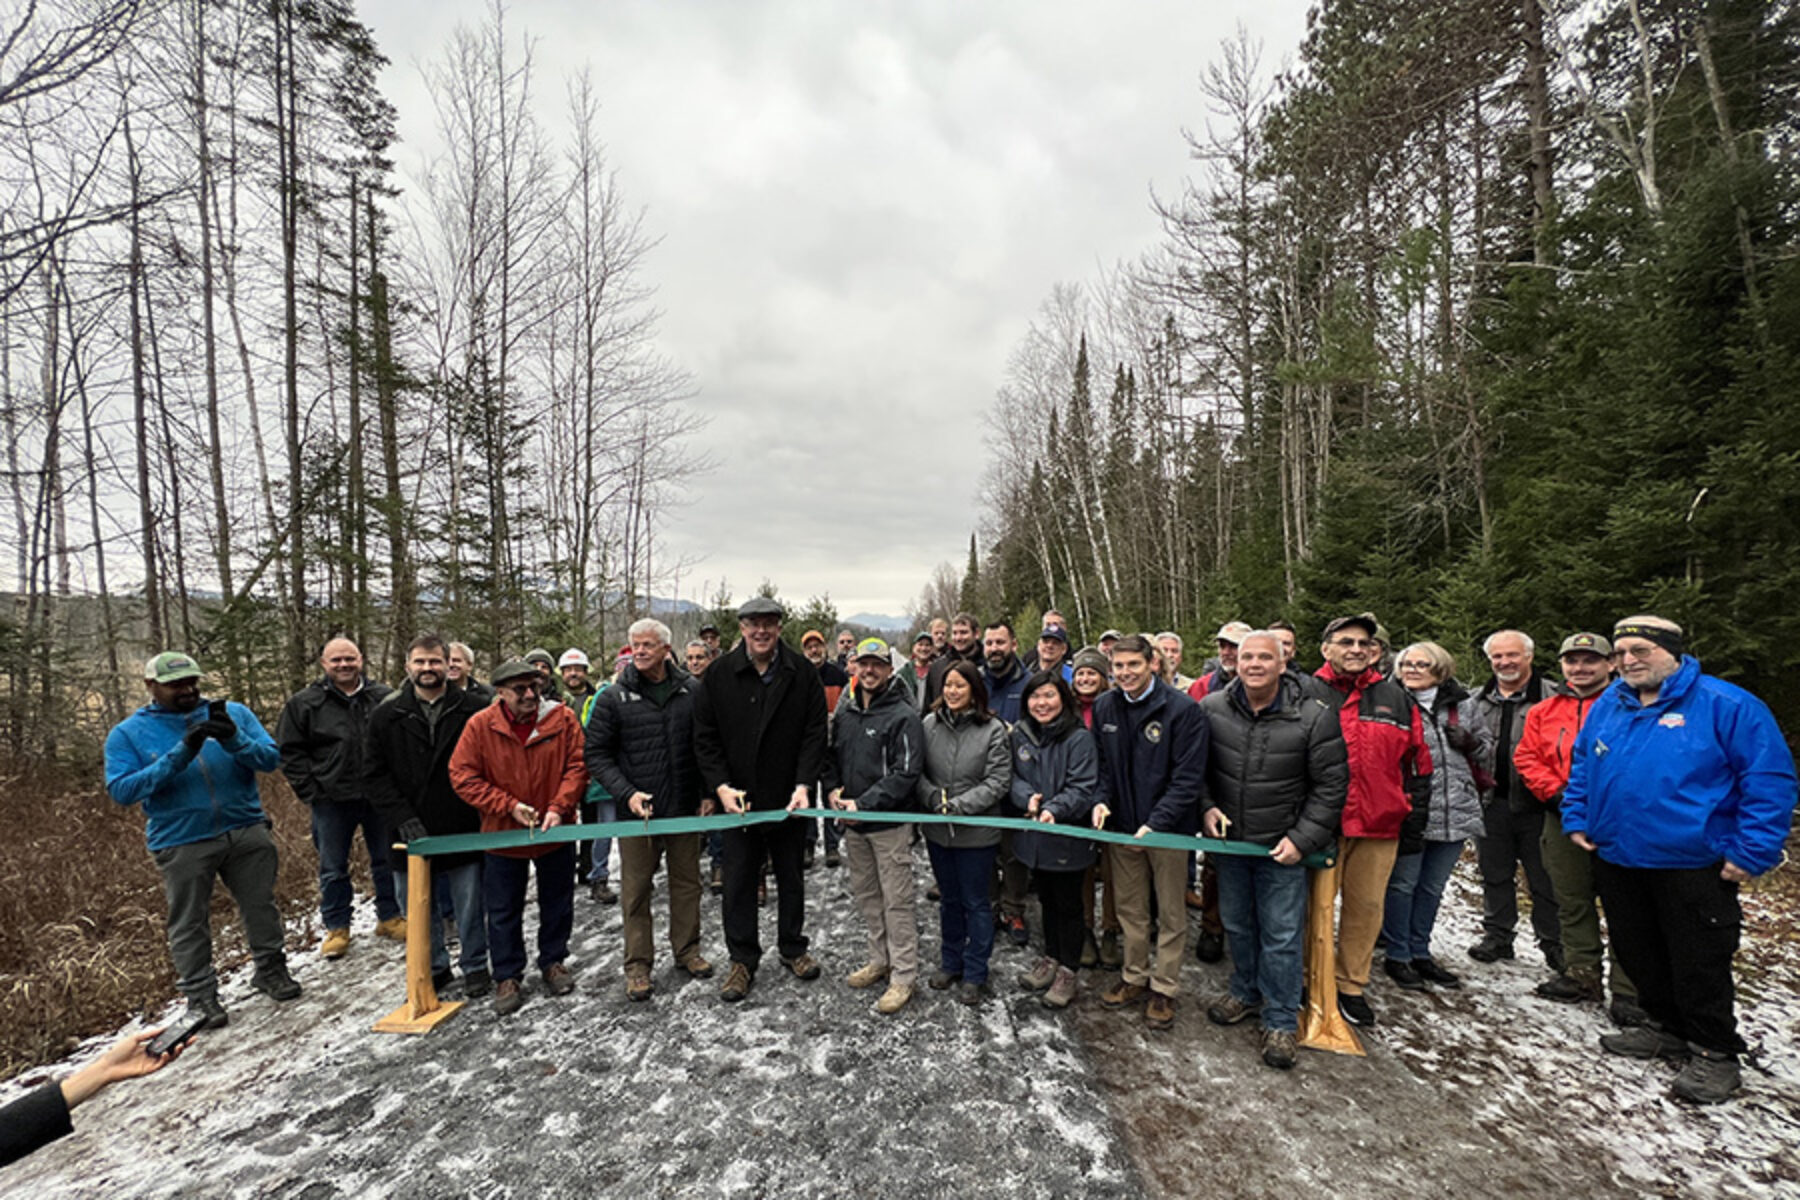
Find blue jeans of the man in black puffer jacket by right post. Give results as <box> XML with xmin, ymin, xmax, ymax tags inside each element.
<box><xmin>1208</xmin><ymin>855</ymin><xmax>1307</xmax><ymax>1033</ymax></box>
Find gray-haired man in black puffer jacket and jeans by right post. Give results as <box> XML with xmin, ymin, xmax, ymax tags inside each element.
<box><xmin>1201</xmin><ymin>630</ymin><xmax>1350</xmax><ymax>1070</ymax></box>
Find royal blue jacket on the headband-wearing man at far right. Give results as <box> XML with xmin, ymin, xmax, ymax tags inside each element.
<box><xmin>1562</xmin><ymin>655</ymin><xmax>1796</xmax><ymax>874</ymax></box>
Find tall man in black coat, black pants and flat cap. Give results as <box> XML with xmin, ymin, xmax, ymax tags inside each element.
<box><xmin>693</xmin><ymin>596</ymin><xmax>826</xmax><ymax>1000</ymax></box>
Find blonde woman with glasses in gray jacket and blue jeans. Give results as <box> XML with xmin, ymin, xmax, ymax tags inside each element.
<box><xmin>1382</xmin><ymin>642</ymin><xmax>1492</xmax><ymax>991</ymax></box>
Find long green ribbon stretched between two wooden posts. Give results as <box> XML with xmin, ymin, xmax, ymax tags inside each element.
<box><xmin>407</xmin><ymin>808</ymin><xmax>1337</xmax><ymax>867</ymax></box>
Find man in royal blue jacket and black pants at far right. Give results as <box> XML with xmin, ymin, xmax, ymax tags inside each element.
<box><xmin>1562</xmin><ymin>615</ymin><xmax>1796</xmax><ymax>1105</ymax></box>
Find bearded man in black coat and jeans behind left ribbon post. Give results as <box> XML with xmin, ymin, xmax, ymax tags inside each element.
<box><xmin>364</xmin><ymin>633</ymin><xmax>493</xmax><ymax>997</ymax></box>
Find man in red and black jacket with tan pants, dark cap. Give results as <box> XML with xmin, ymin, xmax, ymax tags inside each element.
<box><xmin>1309</xmin><ymin>612</ymin><xmax>1431</xmax><ymax>1025</ymax></box>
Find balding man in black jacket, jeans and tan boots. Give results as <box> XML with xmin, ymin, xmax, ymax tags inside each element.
<box><xmin>275</xmin><ymin>637</ymin><xmax>407</xmax><ymax>959</ymax></box>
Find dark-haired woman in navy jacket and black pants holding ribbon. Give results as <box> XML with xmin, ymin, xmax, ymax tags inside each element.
<box><xmin>1006</xmin><ymin>671</ymin><xmax>1100</xmax><ymax>1007</ymax></box>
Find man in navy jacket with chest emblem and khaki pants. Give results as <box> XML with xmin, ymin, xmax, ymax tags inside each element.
<box><xmin>1094</xmin><ymin>633</ymin><xmax>1210</xmax><ymax>1029</ymax></box>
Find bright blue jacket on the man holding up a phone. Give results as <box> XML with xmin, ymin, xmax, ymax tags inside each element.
<box><xmin>106</xmin><ymin>700</ymin><xmax>281</xmax><ymax>851</ymax></box>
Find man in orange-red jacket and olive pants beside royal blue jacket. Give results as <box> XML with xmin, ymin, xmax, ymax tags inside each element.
<box><xmin>1512</xmin><ymin>633</ymin><xmax>1643</xmax><ymax>1027</ymax></box>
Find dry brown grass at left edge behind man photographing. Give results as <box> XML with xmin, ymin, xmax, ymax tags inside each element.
<box><xmin>0</xmin><ymin>772</ymin><xmax>319</xmax><ymax>1079</ymax></box>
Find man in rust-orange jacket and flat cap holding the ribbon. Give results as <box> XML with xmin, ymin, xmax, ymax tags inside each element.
<box><xmin>450</xmin><ymin>660</ymin><xmax>587</xmax><ymax>1016</ymax></box>
